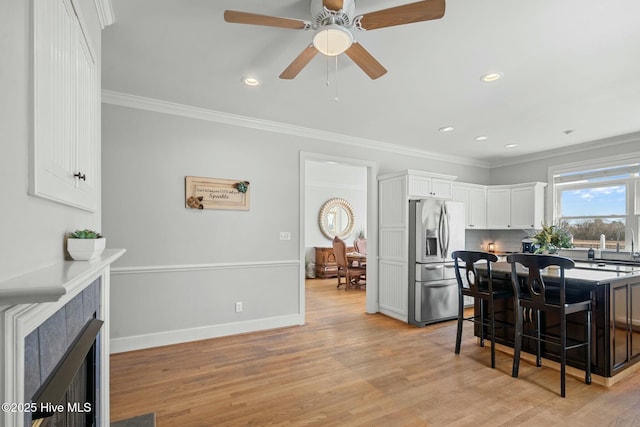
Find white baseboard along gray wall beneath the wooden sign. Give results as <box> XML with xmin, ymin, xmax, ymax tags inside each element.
<box><xmin>110</xmin><ymin>314</ymin><xmax>304</xmax><ymax>354</ymax></box>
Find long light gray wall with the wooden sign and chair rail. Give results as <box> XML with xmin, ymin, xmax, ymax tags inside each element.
<box><xmin>102</xmin><ymin>104</ymin><xmax>489</xmax><ymax>351</ymax></box>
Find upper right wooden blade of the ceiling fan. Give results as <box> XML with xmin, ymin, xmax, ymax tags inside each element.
<box><xmin>360</xmin><ymin>0</ymin><xmax>445</xmax><ymax>30</ymax></box>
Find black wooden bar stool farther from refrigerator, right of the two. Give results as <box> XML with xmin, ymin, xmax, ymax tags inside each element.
<box><xmin>507</xmin><ymin>254</ymin><xmax>592</xmax><ymax>397</ymax></box>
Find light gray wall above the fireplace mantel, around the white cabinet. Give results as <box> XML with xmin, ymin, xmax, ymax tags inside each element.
<box><xmin>0</xmin><ymin>0</ymin><xmax>101</xmax><ymax>281</ymax></box>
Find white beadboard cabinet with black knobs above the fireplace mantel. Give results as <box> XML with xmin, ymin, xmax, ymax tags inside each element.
<box><xmin>29</xmin><ymin>0</ymin><xmax>100</xmax><ymax>211</ymax></box>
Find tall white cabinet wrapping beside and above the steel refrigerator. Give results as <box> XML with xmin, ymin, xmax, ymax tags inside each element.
<box><xmin>378</xmin><ymin>170</ymin><xmax>456</xmax><ymax>322</ymax></box>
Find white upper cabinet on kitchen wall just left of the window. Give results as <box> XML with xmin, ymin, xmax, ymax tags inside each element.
<box><xmin>487</xmin><ymin>182</ymin><xmax>547</xmax><ymax>229</ymax></box>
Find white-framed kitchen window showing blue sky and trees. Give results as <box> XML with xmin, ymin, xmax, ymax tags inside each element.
<box><xmin>553</xmin><ymin>162</ymin><xmax>640</xmax><ymax>251</ymax></box>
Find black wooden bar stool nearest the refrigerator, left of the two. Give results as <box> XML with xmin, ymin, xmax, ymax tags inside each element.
<box><xmin>451</xmin><ymin>251</ymin><xmax>513</xmax><ymax>368</ymax></box>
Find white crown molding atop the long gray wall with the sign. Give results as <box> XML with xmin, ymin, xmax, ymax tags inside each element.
<box><xmin>102</xmin><ymin>90</ymin><xmax>489</xmax><ymax>168</ymax></box>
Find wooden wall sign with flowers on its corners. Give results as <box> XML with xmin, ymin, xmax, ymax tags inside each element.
<box><xmin>185</xmin><ymin>176</ymin><xmax>249</xmax><ymax>211</ymax></box>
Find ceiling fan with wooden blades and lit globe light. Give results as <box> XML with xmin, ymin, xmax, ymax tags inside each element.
<box><xmin>224</xmin><ymin>0</ymin><xmax>445</xmax><ymax>79</ymax></box>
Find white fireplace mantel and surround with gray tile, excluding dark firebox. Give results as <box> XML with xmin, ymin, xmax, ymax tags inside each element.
<box><xmin>0</xmin><ymin>249</ymin><xmax>125</xmax><ymax>427</ymax></box>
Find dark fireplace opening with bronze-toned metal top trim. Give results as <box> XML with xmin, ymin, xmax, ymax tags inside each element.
<box><xmin>31</xmin><ymin>319</ymin><xmax>104</xmax><ymax>427</ymax></box>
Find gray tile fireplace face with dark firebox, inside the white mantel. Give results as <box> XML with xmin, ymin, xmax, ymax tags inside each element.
<box><xmin>24</xmin><ymin>280</ymin><xmax>103</xmax><ymax>427</ymax></box>
